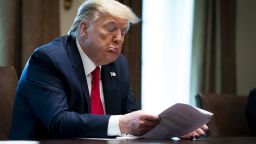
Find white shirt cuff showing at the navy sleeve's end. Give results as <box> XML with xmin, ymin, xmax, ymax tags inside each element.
<box><xmin>107</xmin><ymin>115</ymin><xmax>121</xmax><ymax>136</ymax></box>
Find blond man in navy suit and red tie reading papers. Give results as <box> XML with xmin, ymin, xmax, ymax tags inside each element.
<box><xmin>9</xmin><ymin>0</ymin><xmax>208</xmax><ymax>139</ymax></box>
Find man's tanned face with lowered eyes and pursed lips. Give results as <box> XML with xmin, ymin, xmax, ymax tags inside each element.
<box><xmin>79</xmin><ymin>16</ymin><xmax>128</xmax><ymax>65</ymax></box>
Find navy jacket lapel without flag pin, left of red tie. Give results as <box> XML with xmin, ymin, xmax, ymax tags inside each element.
<box><xmin>67</xmin><ymin>36</ymin><xmax>90</xmax><ymax>112</ymax></box>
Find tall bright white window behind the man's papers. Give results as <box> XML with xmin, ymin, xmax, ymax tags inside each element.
<box><xmin>142</xmin><ymin>0</ymin><xmax>193</xmax><ymax>114</ymax></box>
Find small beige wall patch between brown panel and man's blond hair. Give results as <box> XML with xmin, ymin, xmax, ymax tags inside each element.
<box><xmin>60</xmin><ymin>0</ymin><xmax>83</xmax><ymax>35</ymax></box>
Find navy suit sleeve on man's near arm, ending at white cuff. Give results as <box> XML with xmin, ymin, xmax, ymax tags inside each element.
<box><xmin>20</xmin><ymin>49</ymin><xmax>109</xmax><ymax>138</ymax></box>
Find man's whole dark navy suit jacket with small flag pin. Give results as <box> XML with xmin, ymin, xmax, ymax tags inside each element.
<box><xmin>9</xmin><ymin>36</ymin><xmax>137</xmax><ymax>139</ymax></box>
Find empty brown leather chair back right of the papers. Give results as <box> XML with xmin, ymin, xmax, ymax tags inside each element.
<box><xmin>196</xmin><ymin>94</ymin><xmax>249</xmax><ymax>137</ymax></box>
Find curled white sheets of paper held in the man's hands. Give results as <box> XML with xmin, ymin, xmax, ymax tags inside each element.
<box><xmin>141</xmin><ymin>103</ymin><xmax>213</xmax><ymax>139</ymax></box>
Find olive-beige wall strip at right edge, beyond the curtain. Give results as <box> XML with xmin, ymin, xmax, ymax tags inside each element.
<box><xmin>236</xmin><ymin>0</ymin><xmax>256</xmax><ymax>95</ymax></box>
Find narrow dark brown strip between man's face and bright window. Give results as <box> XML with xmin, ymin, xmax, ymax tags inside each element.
<box><xmin>119</xmin><ymin>0</ymin><xmax>142</xmax><ymax>108</ymax></box>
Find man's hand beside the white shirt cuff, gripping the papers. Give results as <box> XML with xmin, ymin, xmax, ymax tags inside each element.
<box><xmin>119</xmin><ymin>110</ymin><xmax>160</xmax><ymax>136</ymax></box>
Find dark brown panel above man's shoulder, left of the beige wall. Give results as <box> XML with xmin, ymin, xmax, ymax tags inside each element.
<box><xmin>22</xmin><ymin>0</ymin><xmax>60</xmax><ymax>67</ymax></box>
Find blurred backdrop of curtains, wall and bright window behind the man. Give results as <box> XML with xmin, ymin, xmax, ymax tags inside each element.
<box><xmin>0</xmin><ymin>0</ymin><xmax>256</xmax><ymax>113</ymax></box>
